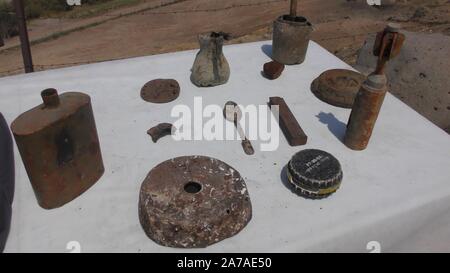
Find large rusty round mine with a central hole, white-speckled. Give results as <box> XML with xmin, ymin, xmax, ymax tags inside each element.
<box><xmin>139</xmin><ymin>156</ymin><xmax>252</xmax><ymax>248</ymax></box>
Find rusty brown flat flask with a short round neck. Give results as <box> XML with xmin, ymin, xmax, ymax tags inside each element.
<box><xmin>11</xmin><ymin>89</ymin><xmax>104</xmax><ymax>209</ymax></box>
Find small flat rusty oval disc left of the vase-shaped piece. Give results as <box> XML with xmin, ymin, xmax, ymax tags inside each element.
<box><xmin>141</xmin><ymin>79</ymin><xmax>180</xmax><ymax>103</ymax></box>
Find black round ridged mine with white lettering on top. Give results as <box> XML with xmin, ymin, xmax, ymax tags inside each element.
<box><xmin>287</xmin><ymin>149</ymin><xmax>343</xmax><ymax>198</ymax></box>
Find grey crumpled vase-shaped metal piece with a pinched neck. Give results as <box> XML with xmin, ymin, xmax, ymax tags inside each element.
<box><xmin>191</xmin><ymin>32</ymin><xmax>230</xmax><ymax>87</ymax></box>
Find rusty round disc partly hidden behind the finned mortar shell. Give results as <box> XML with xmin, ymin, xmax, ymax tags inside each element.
<box><xmin>311</xmin><ymin>69</ymin><xmax>366</xmax><ymax>108</ymax></box>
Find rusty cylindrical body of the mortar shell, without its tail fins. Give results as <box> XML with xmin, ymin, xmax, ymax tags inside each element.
<box><xmin>344</xmin><ymin>74</ymin><xmax>387</xmax><ymax>150</ymax></box>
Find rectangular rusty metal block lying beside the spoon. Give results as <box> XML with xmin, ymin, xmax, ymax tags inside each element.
<box><xmin>269</xmin><ymin>97</ymin><xmax>308</xmax><ymax>146</ymax></box>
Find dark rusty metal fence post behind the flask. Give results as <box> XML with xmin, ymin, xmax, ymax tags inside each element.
<box><xmin>13</xmin><ymin>0</ymin><xmax>34</xmax><ymax>73</ymax></box>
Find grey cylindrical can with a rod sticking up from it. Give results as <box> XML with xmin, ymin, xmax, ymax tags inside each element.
<box><xmin>272</xmin><ymin>15</ymin><xmax>313</xmax><ymax>65</ymax></box>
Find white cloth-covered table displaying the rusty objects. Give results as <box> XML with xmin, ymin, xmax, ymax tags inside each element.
<box><xmin>0</xmin><ymin>42</ymin><xmax>450</xmax><ymax>252</ymax></box>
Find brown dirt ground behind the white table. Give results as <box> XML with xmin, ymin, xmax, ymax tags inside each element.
<box><xmin>0</xmin><ymin>0</ymin><xmax>450</xmax><ymax>76</ymax></box>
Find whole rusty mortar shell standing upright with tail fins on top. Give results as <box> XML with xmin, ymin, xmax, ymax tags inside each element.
<box><xmin>344</xmin><ymin>24</ymin><xmax>405</xmax><ymax>150</ymax></box>
